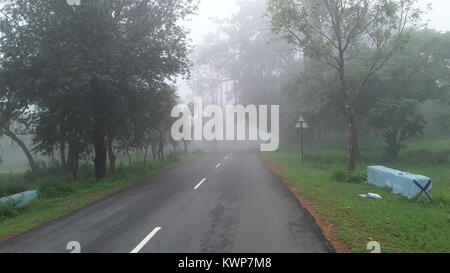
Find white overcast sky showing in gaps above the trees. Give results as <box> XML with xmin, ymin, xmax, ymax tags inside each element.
<box><xmin>179</xmin><ymin>0</ymin><xmax>450</xmax><ymax>99</ymax></box>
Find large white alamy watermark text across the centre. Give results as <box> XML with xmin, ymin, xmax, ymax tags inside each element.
<box><xmin>171</xmin><ymin>97</ymin><xmax>280</xmax><ymax>152</ymax></box>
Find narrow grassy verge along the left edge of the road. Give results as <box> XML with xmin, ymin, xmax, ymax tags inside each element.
<box><xmin>0</xmin><ymin>154</ymin><xmax>200</xmax><ymax>241</ymax></box>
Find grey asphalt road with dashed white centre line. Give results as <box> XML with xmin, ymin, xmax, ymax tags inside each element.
<box><xmin>0</xmin><ymin>151</ymin><xmax>333</xmax><ymax>253</ymax></box>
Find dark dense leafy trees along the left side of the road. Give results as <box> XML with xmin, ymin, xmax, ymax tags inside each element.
<box><xmin>0</xmin><ymin>0</ymin><xmax>195</xmax><ymax>180</ymax></box>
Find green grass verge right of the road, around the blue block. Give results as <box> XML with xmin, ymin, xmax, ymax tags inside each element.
<box><xmin>263</xmin><ymin>139</ymin><xmax>450</xmax><ymax>253</ymax></box>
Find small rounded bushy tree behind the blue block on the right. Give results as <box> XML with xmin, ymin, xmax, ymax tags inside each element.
<box><xmin>370</xmin><ymin>99</ymin><xmax>425</xmax><ymax>159</ymax></box>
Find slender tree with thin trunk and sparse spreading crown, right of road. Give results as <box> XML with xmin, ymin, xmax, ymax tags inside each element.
<box><xmin>267</xmin><ymin>0</ymin><xmax>421</xmax><ymax>171</ymax></box>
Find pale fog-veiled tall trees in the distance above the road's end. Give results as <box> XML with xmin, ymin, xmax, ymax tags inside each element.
<box><xmin>192</xmin><ymin>0</ymin><xmax>292</xmax><ymax>105</ymax></box>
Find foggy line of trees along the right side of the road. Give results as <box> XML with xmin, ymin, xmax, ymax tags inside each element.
<box><xmin>193</xmin><ymin>0</ymin><xmax>450</xmax><ymax>170</ymax></box>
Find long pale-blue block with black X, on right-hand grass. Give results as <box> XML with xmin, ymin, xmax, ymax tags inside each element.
<box><xmin>367</xmin><ymin>166</ymin><xmax>432</xmax><ymax>198</ymax></box>
